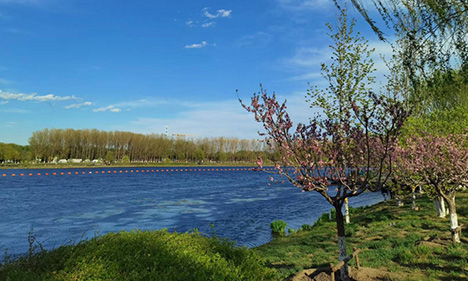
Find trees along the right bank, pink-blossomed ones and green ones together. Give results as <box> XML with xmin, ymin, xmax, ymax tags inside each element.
<box><xmin>241</xmin><ymin>0</ymin><xmax>468</xmax><ymax>280</ymax></box>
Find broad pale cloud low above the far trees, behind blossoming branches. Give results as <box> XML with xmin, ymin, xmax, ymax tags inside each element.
<box><xmin>115</xmin><ymin>92</ymin><xmax>314</xmax><ymax>139</ymax></box>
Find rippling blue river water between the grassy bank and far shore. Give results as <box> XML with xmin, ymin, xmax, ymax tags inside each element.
<box><xmin>0</xmin><ymin>167</ymin><xmax>383</xmax><ymax>256</ymax></box>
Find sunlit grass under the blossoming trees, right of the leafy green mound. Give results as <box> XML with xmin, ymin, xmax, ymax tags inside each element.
<box><xmin>255</xmin><ymin>193</ymin><xmax>468</xmax><ymax>280</ymax></box>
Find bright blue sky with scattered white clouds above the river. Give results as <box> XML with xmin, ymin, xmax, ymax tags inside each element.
<box><xmin>0</xmin><ymin>0</ymin><xmax>390</xmax><ymax>145</ymax></box>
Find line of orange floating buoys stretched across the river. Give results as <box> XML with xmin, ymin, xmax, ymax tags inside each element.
<box><xmin>0</xmin><ymin>167</ymin><xmax>275</xmax><ymax>178</ymax></box>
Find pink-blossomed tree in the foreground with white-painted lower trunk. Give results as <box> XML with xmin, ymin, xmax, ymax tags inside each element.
<box><xmin>240</xmin><ymin>7</ymin><xmax>407</xmax><ymax>280</ymax></box>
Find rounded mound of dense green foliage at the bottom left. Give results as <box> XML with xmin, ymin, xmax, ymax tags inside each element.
<box><xmin>0</xmin><ymin>230</ymin><xmax>272</xmax><ymax>280</ymax></box>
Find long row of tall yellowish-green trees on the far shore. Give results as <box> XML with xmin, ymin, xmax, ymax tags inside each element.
<box><xmin>29</xmin><ymin>129</ymin><xmax>275</xmax><ymax>162</ymax></box>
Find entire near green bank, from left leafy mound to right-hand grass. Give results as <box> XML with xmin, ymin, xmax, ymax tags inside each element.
<box><xmin>0</xmin><ymin>193</ymin><xmax>468</xmax><ymax>280</ymax></box>
